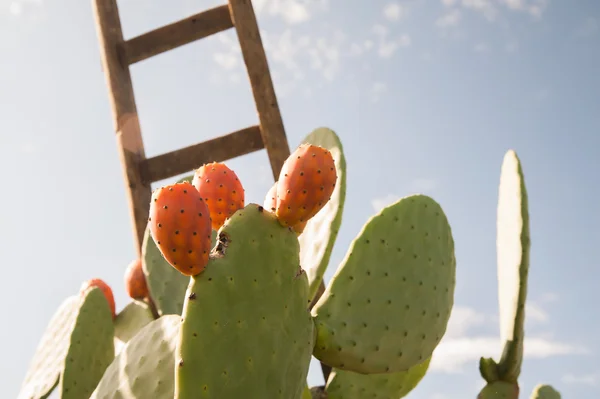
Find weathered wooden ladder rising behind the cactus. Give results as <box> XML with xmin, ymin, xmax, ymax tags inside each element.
<box><xmin>93</xmin><ymin>0</ymin><xmax>290</xmax><ymax>256</ymax></box>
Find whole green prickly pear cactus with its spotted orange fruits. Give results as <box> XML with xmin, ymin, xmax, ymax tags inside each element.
<box><xmin>19</xmin><ymin>128</ymin><xmax>572</xmax><ymax>399</ymax></box>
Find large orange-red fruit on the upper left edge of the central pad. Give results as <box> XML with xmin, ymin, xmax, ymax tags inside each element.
<box><xmin>148</xmin><ymin>181</ymin><xmax>212</xmax><ymax>276</ymax></box>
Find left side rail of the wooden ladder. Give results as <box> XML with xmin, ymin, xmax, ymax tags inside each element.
<box><xmin>93</xmin><ymin>0</ymin><xmax>152</xmax><ymax>256</ymax></box>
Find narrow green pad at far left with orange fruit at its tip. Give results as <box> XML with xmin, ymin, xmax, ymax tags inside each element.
<box><xmin>58</xmin><ymin>288</ymin><xmax>115</xmax><ymax>399</ymax></box>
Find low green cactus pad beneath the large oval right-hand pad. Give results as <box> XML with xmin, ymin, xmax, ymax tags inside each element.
<box><xmin>325</xmin><ymin>358</ymin><xmax>431</xmax><ymax>399</ymax></box>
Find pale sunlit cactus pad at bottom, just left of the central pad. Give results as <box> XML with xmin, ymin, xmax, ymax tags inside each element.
<box><xmin>90</xmin><ymin>315</ymin><xmax>181</xmax><ymax>399</ymax></box>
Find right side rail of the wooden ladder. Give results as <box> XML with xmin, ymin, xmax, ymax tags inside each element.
<box><xmin>229</xmin><ymin>0</ymin><xmax>290</xmax><ymax>180</ymax></box>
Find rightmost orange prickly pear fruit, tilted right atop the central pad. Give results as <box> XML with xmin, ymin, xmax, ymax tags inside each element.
<box><xmin>275</xmin><ymin>144</ymin><xmax>337</xmax><ymax>230</ymax></box>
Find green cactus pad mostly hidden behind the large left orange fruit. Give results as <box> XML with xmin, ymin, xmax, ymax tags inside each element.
<box><xmin>142</xmin><ymin>227</ymin><xmax>217</xmax><ymax>316</ymax></box>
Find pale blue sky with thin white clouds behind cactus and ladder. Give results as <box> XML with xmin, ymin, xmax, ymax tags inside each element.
<box><xmin>0</xmin><ymin>0</ymin><xmax>600</xmax><ymax>399</ymax></box>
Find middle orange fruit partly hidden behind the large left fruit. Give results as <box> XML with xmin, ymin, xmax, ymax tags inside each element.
<box><xmin>192</xmin><ymin>162</ymin><xmax>244</xmax><ymax>230</ymax></box>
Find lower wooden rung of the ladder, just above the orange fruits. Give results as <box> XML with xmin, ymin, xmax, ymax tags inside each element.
<box><xmin>142</xmin><ymin>126</ymin><xmax>264</xmax><ymax>183</ymax></box>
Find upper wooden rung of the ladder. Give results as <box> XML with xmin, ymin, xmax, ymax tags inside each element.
<box><xmin>125</xmin><ymin>4</ymin><xmax>233</xmax><ymax>65</ymax></box>
